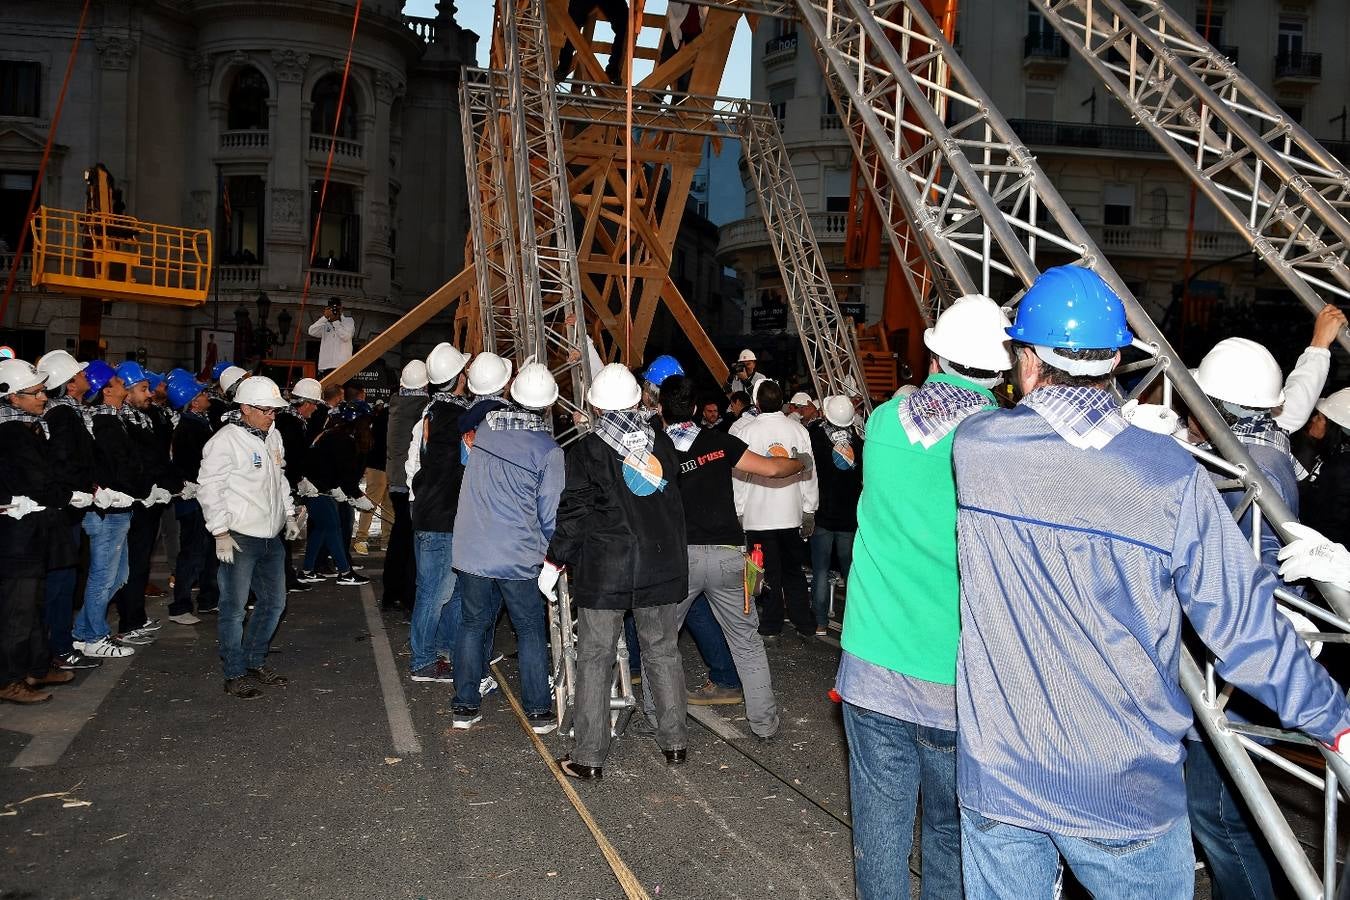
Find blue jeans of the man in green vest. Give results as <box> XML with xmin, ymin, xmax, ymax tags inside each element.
<box><xmin>844</xmin><ymin>703</ymin><xmax>961</xmax><ymax>900</ymax></box>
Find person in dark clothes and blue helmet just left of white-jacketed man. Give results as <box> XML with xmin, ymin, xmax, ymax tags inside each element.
<box><xmin>169</xmin><ymin>375</ymin><xmax>220</xmax><ymax>625</ymax></box>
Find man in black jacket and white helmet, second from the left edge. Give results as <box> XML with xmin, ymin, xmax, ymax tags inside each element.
<box><xmin>38</xmin><ymin>349</ymin><xmax>103</xmax><ymax>671</ymax></box>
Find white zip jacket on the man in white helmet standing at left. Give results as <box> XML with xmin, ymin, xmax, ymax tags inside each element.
<box><xmin>197</xmin><ymin>424</ymin><xmax>296</xmax><ymax>537</ymax></box>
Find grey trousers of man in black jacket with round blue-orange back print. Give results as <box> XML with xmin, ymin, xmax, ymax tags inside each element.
<box><xmin>572</xmin><ymin>603</ymin><xmax>689</xmax><ymax>766</ymax></box>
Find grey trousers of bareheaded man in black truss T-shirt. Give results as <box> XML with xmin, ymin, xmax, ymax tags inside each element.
<box><xmin>666</xmin><ymin>544</ymin><xmax>778</xmax><ymax>738</ymax></box>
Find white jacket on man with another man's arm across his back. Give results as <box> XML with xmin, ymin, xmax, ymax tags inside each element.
<box><xmin>732</xmin><ymin>412</ymin><xmax>821</xmax><ymax>532</ymax></box>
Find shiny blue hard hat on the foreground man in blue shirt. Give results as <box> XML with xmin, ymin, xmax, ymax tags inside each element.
<box><xmin>1007</xmin><ymin>266</ymin><xmax>1134</xmax><ymax>349</ymax></box>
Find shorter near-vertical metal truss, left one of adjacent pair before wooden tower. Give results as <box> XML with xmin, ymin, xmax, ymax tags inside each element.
<box><xmin>459</xmin><ymin>69</ymin><xmax>527</xmax><ymax>359</ymax></box>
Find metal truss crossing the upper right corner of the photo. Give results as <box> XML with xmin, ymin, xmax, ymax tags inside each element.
<box><xmin>1033</xmin><ymin>0</ymin><xmax>1350</xmax><ymax>358</ymax></box>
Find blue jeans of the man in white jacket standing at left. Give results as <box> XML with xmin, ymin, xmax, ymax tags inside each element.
<box><xmin>216</xmin><ymin>532</ymin><xmax>286</xmax><ymax>679</ymax></box>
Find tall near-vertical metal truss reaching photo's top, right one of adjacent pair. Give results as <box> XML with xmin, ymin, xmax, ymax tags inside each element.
<box><xmin>498</xmin><ymin>0</ymin><xmax>590</xmax><ymax>444</ymax></box>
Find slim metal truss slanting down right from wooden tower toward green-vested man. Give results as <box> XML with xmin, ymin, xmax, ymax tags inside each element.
<box><xmin>738</xmin><ymin>104</ymin><xmax>872</xmax><ymax>413</ymax></box>
